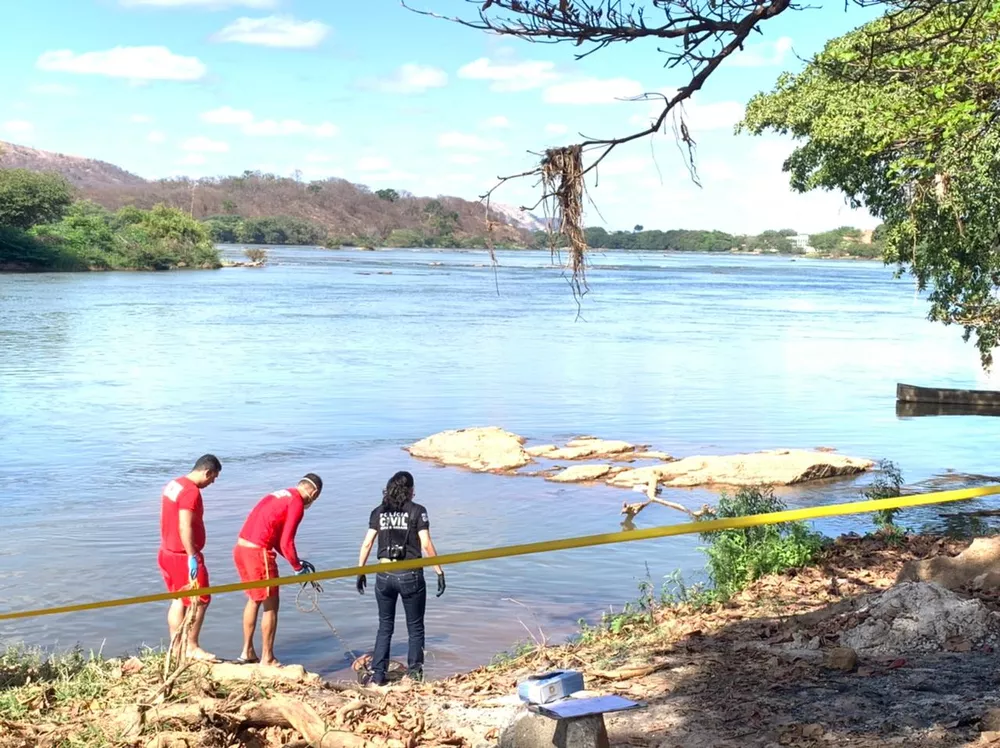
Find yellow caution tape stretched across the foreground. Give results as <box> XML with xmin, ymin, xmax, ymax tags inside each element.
<box><xmin>0</xmin><ymin>485</ymin><xmax>1000</xmax><ymax>621</ymax></box>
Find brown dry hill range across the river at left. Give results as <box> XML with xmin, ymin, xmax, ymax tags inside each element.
<box><xmin>0</xmin><ymin>143</ymin><xmax>532</xmax><ymax>246</ymax></box>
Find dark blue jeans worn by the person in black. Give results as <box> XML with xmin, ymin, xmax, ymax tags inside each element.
<box><xmin>372</xmin><ymin>569</ymin><xmax>427</xmax><ymax>684</ymax></box>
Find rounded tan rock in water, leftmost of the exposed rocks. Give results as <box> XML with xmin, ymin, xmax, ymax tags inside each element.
<box><xmin>406</xmin><ymin>426</ymin><xmax>531</xmax><ymax>473</ymax></box>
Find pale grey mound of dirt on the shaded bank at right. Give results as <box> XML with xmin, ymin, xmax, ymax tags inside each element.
<box><xmin>840</xmin><ymin>582</ymin><xmax>1000</xmax><ymax>656</ymax></box>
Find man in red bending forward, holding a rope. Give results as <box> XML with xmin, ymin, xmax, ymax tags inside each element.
<box><xmin>233</xmin><ymin>473</ymin><xmax>323</xmax><ymax>665</ymax></box>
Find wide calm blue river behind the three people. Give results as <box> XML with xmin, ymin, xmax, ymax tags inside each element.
<box><xmin>0</xmin><ymin>248</ymin><xmax>997</xmax><ymax>677</ymax></box>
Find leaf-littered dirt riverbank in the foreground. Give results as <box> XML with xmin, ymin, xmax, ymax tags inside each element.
<box><xmin>0</xmin><ymin>534</ymin><xmax>1000</xmax><ymax>748</ymax></box>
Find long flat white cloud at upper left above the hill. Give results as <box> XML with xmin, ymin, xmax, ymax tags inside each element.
<box><xmin>36</xmin><ymin>47</ymin><xmax>207</xmax><ymax>81</ymax></box>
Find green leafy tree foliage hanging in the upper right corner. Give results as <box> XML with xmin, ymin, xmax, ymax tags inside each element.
<box><xmin>742</xmin><ymin>0</ymin><xmax>1000</xmax><ymax>366</ymax></box>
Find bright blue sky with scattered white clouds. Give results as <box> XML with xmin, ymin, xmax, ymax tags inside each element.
<box><xmin>0</xmin><ymin>0</ymin><xmax>875</xmax><ymax>233</ymax></box>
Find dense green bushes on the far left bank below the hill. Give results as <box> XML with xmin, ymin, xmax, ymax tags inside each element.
<box><xmin>0</xmin><ymin>169</ymin><xmax>221</xmax><ymax>270</ymax></box>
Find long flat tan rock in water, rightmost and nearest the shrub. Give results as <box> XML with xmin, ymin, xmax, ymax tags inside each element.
<box><xmin>608</xmin><ymin>449</ymin><xmax>875</xmax><ymax>488</ymax></box>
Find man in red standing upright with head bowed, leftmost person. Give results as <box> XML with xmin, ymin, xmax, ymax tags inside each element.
<box><xmin>157</xmin><ymin>455</ymin><xmax>222</xmax><ymax>660</ymax></box>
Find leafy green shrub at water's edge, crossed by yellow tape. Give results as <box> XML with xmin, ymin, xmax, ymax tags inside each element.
<box><xmin>701</xmin><ymin>487</ymin><xmax>822</xmax><ymax>598</ymax></box>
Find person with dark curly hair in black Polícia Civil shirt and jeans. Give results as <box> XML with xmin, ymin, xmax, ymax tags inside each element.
<box><xmin>357</xmin><ymin>470</ymin><xmax>445</xmax><ymax>685</ymax></box>
